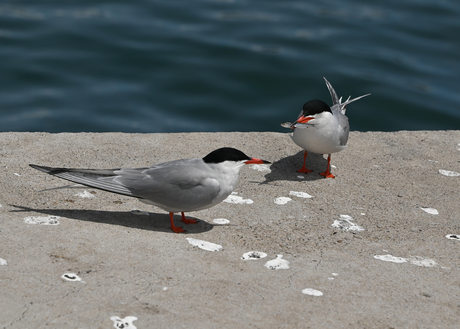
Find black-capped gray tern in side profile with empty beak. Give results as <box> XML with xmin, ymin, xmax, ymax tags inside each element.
<box><xmin>30</xmin><ymin>147</ymin><xmax>270</xmax><ymax>233</ymax></box>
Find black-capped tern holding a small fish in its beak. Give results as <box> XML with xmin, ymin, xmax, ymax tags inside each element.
<box><xmin>281</xmin><ymin>77</ymin><xmax>370</xmax><ymax>178</ymax></box>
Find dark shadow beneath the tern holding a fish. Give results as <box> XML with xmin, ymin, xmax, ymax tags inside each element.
<box><xmin>262</xmin><ymin>151</ymin><xmax>327</xmax><ymax>184</ymax></box>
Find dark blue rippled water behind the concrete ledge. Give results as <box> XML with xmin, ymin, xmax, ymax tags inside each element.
<box><xmin>0</xmin><ymin>0</ymin><xmax>460</xmax><ymax>132</ymax></box>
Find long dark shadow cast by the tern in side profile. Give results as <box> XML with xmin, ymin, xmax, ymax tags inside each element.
<box><xmin>10</xmin><ymin>205</ymin><xmax>215</xmax><ymax>234</ymax></box>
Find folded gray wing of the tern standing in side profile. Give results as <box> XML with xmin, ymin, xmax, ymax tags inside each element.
<box><xmin>30</xmin><ymin>159</ymin><xmax>221</xmax><ymax>210</ymax></box>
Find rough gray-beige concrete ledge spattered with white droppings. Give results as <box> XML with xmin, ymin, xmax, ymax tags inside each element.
<box><xmin>0</xmin><ymin>131</ymin><xmax>460</xmax><ymax>329</ymax></box>
